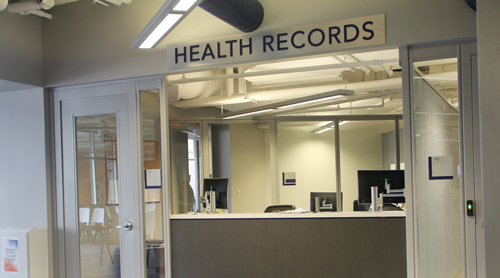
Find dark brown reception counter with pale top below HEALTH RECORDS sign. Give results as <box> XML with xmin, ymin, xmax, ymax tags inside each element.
<box><xmin>170</xmin><ymin>211</ymin><xmax>406</xmax><ymax>278</ymax></box>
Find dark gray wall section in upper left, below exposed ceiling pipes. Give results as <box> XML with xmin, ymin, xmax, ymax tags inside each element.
<box><xmin>0</xmin><ymin>10</ymin><xmax>43</xmax><ymax>87</ymax></box>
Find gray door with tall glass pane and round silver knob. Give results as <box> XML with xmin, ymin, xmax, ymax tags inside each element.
<box><xmin>59</xmin><ymin>88</ymin><xmax>144</xmax><ymax>278</ymax></box>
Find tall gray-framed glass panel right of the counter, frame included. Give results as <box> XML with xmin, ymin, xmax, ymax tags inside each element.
<box><xmin>401</xmin><ymin>45</ymin><xmax>477</xmax><ymax>277</ymax></box>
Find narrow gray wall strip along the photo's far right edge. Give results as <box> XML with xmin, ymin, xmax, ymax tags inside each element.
<box><xmin>477</xmin><ymin>0</ymin><xmax>500</xmax><ymax>277</ymax></box>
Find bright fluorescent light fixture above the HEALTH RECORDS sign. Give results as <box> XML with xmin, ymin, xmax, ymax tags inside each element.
<box><xmin>132</xmin><ymin>0</ymin><xmax>202</xmax><ymax>49</ymax></box>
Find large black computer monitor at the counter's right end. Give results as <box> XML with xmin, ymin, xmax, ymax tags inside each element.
<box><xmin>358</xmin><ymin>170</ymin><xmax>405</xmax><ymax>203</ymax></box>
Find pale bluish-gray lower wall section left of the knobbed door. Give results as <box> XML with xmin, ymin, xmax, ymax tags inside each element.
<box><xmin>0</xmin><ymin>89</ymin><xmax>50</xmax><ymax>229</ymax></box>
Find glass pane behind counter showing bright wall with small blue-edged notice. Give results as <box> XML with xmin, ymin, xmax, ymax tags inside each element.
<box><xmin>277</xmin><ymin>121</ymin><xmax>336</xmax><ymax>210</ymax></box>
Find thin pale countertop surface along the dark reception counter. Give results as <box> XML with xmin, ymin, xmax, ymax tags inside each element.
<box><xmin>170</xmin><ymin>211</ymin><xmax>406</xmax><ymax>220</ymax></box>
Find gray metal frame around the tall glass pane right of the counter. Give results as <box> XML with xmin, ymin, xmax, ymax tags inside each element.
<box><xmin>399</xmin><ymin>42</ymin><xmax>482</xmax><ymax>278</ymax></box>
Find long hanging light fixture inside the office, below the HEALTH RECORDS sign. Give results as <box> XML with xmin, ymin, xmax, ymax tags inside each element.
<box><xmin>216</xmin><ymin>90</ymin><xmax>354</xmax><ymax>119</ymax></box>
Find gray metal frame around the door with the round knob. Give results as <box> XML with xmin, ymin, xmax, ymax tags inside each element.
<box><xmin>51</xmin><ymin>79</ymin><xmax>158</xmax><ymax>278</ymax></box>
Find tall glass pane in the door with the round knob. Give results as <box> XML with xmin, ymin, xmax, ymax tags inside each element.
<box><xmin>76</xmin><ymin>114</ymin><xmax>120</xmax><ymax>278</ymax></box>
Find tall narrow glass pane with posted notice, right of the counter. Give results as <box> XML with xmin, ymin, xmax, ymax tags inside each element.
<box><xmin>413</xmin><ymin>59</ymin><xmax>462</xmax><ymax>277</ymax></box>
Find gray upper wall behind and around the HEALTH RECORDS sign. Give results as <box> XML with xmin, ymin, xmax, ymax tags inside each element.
<box><xmin>43</xmin><ymin>0</ymin><xmax>476</xmax><ymax>86</ymax></box>
